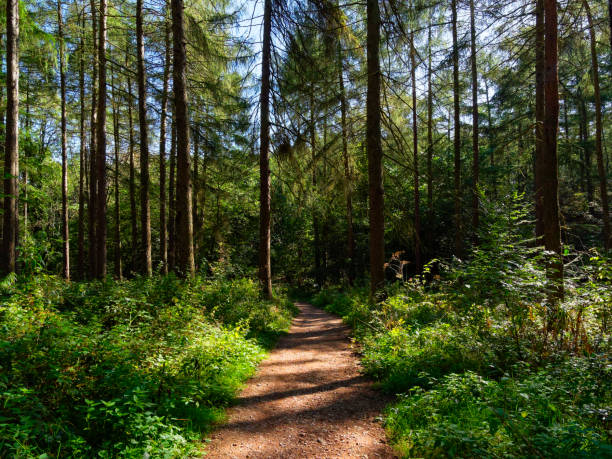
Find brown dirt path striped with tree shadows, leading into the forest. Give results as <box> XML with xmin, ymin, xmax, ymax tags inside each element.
<box><xmin>206</xmin><ymin>303</ymin><xmax>395</xmax><ymax>459</ymax></box>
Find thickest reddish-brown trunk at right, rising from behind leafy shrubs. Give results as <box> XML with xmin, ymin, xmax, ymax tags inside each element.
<box><xmin>541</xmin><ymin>0</ymin><xmax>563</xmax><ymax>298</ymax></box>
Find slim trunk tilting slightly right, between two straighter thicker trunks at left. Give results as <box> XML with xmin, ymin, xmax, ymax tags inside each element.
<box><xmin>159</xmin><ymin>18</ymin><xmax>170</xmax><ymax>274</ymax></box>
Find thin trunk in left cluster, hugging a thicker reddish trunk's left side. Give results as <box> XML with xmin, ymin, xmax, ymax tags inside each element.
<box><xmin>87</xmin><ymin>0</ymin><xmax>98</xmax><ymax>278</ymax></box>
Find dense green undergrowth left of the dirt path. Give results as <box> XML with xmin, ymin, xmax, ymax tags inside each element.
<box><xmin>0</xmin><ymin>274</ymin><xmax>295</xmax><ymax>458</ymax></box>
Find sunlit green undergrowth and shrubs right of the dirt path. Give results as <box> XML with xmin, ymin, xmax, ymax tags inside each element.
<box><xmin>313</xmin><ymin>199</ymin><xmax>612</xmax><ymax>458</ymax></box>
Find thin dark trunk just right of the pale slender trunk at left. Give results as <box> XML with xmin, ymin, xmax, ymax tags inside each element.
<box><xmin>77</xmin><ymin>8</ymin><xmax>85</xmax><ymax>280</ymax></box>
